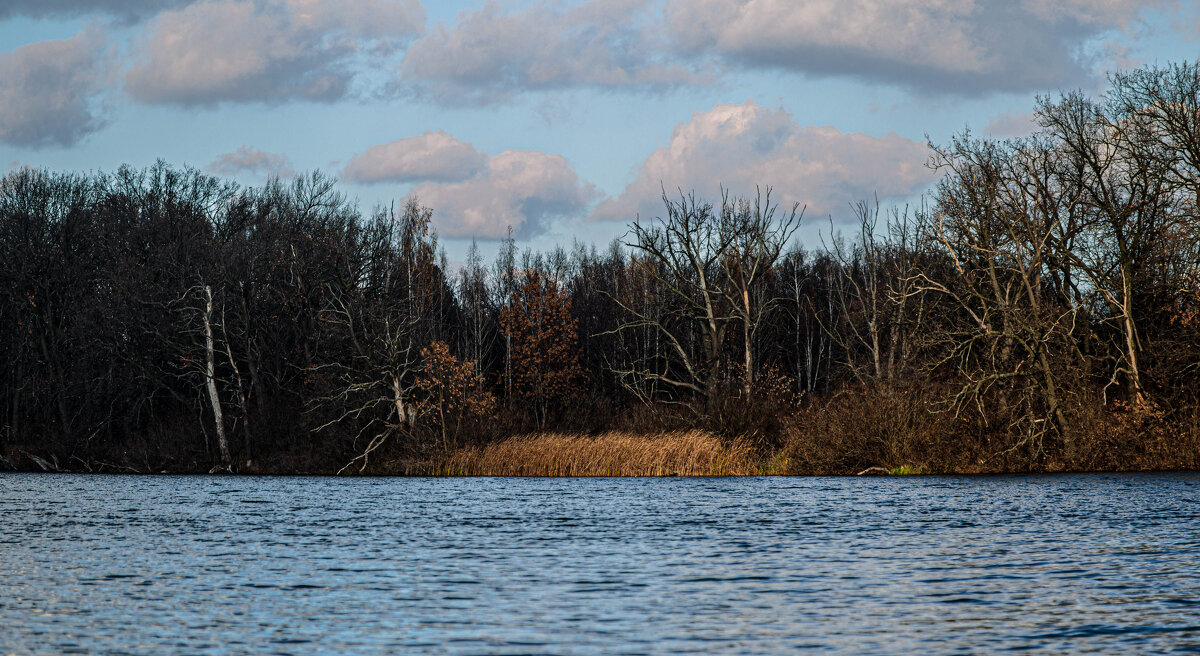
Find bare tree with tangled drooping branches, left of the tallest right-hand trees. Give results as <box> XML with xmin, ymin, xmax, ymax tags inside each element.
<box><xmin>918</xmin><ymin>134</ymin><xmax>1076</xmax><ymax>453</ymax></box>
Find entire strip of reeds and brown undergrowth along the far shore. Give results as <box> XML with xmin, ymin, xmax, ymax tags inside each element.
<box><xmin>9</xmin><ymin>385</ymin><xmax>1200</xmax><ymax>476</ymax></box>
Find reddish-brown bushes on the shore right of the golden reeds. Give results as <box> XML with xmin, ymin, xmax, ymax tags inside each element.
<box><xmin>775</xmin><ymin>384</ymin><xmax>1200</xmax><ymax>475</ymax></box>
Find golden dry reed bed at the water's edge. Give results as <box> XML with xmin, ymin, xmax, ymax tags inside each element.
<box><xmin>440</xmin><ymin>431</ymin><xmax>758</xmax><ymax>476</ymax></box>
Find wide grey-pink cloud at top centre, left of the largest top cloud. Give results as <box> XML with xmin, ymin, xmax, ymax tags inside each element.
<box><xmin>401</xmin><ymin>0</ymin><xmax>708</xmax><ymax>103</ymax></box>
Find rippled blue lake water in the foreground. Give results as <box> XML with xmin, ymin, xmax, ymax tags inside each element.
<box><xmin>0</xmin><ymin>474</ymin><xmax>1200</xmax><ymax>654</ymax></box>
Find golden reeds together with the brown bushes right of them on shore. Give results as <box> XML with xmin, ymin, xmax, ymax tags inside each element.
<box><xmin>426</xmin><ymin>386</ymin><xmax>1200</xmax><ymax>476</ymax></box>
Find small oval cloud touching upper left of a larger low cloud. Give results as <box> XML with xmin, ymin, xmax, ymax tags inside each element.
<box><xmin>342</xmin><ymin>130</ymin><xmax>487</xmax><ymax>182</ymax></box>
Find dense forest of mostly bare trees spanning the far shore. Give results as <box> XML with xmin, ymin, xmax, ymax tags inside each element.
<box><xmin>7</xmin><ymin>64</ymin><xmax>1200</xmax><ymax>474</ymax></box>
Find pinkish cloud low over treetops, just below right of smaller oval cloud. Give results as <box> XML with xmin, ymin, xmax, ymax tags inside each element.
<box><xmin>412</xmin><ymin>150</ymin><xmax>596</xmax><ymax>239</ymax></box>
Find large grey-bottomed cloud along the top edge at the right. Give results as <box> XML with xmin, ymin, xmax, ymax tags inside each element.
<box><xmin>666</xmin><ymin>0</ymin><xmax>1168</xmax><ymax>94</ymax></box>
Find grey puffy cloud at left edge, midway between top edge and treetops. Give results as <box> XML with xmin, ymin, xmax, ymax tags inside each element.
<box><xmin>0</xmin><ymin>29</ymin><xmax>110</xmax><ymax>148</ymax></box>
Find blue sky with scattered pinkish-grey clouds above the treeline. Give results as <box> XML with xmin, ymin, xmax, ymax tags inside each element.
<box><xmin>0</xmin><ymin>0</ymin><xmax>1200</xmax><ymax>259</ymax></box>
